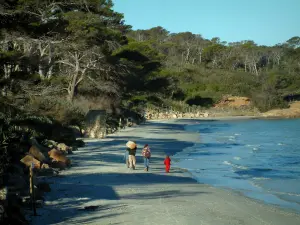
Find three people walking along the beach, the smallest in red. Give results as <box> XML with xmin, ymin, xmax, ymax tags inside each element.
<box><xmin>125</xmin><ymin>141</ymin><xmax>171</xmax><ymax>173</ymax></box>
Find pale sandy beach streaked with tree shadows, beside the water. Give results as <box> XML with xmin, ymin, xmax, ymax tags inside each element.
<box><xmin>32</xmin><ymin>120</ymin><xmax>300</xmax><ymax>225</ymax></box>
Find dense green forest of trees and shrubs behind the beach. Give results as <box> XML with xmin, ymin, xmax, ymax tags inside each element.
<box><xmin>0</xmin><ymin>0</ymin><xmax>300</xmax><ymax>193</ymax></box>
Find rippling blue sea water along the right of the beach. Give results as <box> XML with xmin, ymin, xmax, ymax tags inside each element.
<box><xmin>173</xmin><ymin>119</ymin><xmax>300</xmax><ymax>212</ymax></box>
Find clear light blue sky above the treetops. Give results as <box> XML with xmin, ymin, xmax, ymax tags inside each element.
<box><xmin>114</xmin><ymin>0</ymin><xmax>300</xmax><ymax>46</ymax></box>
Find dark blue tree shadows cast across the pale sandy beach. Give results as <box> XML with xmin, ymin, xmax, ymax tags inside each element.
<box><xmin>34</xmin><ymin>120</ymin><xmax>204</xmax><ymax>225</ymax></box>
